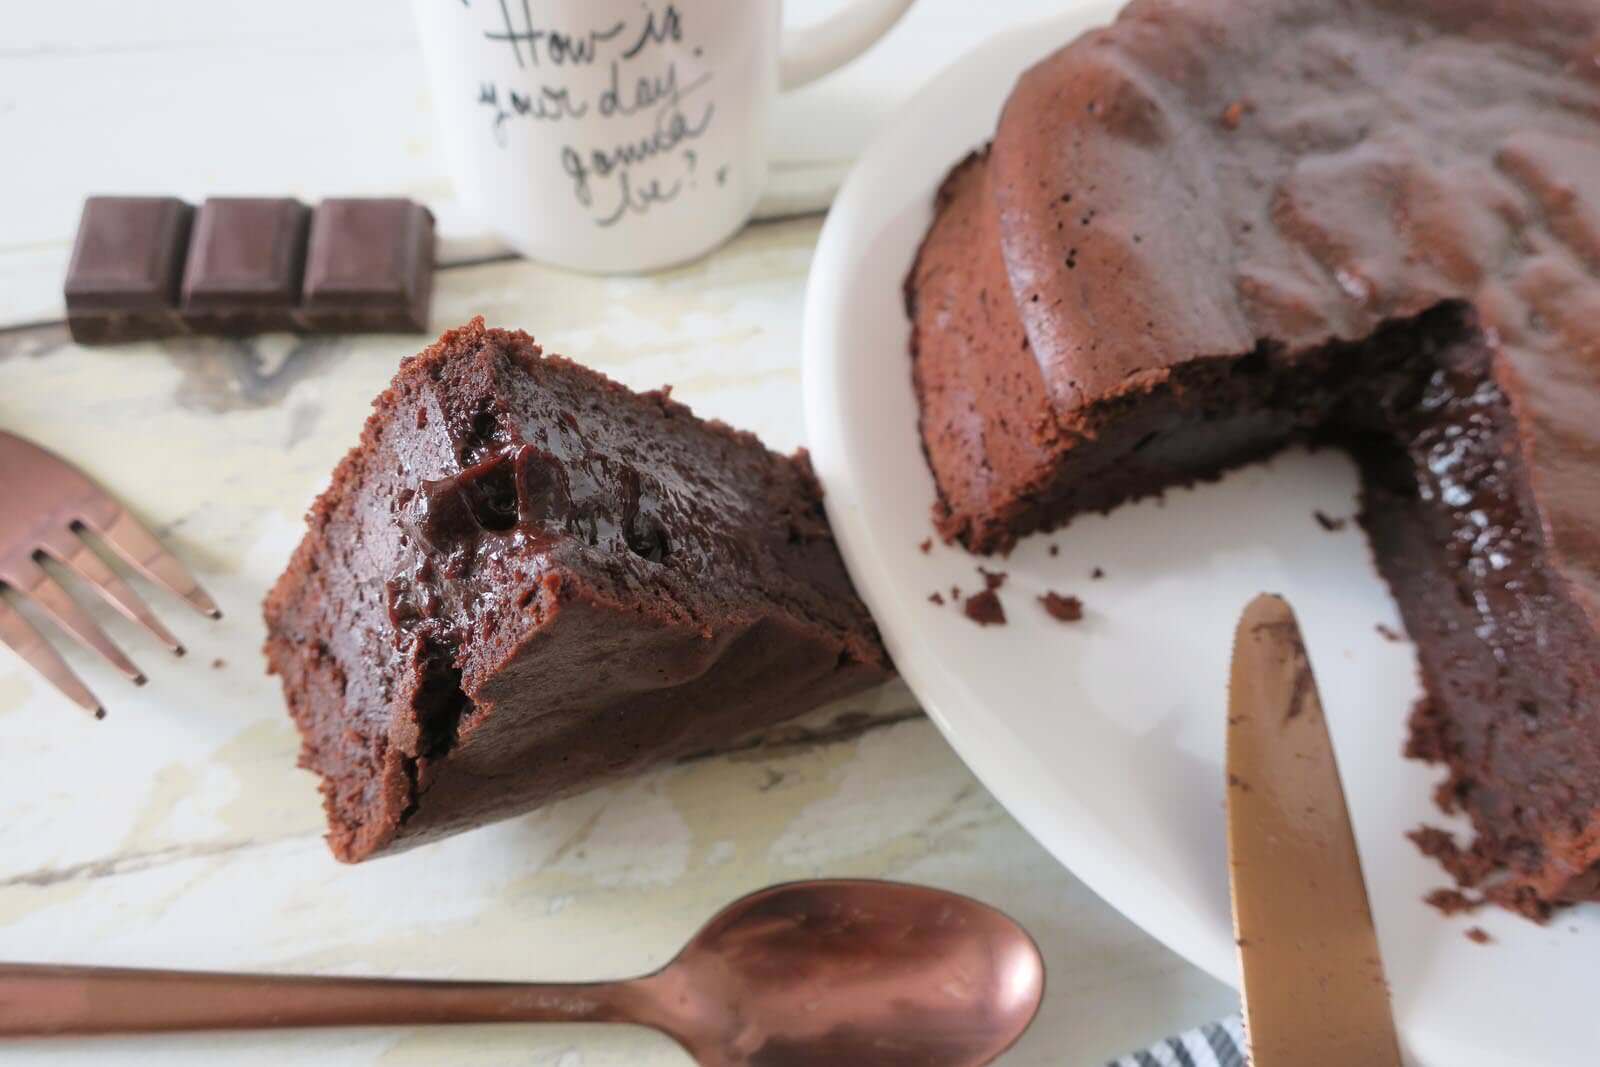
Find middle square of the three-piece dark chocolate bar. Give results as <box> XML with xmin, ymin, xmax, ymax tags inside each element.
<box><xmin>182</xmin><ymin>197</ymin><xmax>309</xmax><ymax>334</ymax></box>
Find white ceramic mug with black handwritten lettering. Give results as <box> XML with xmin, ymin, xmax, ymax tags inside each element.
<box><xmin>413</xmin><ymin>0</ymin><xmax>910</xmax><ymax>274</ymax></box>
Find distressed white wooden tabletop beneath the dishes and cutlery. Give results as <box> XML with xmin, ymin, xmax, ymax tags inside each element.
<box><xmin>0</xmin><ymin>0</ymin><xmax>1235</xmax><ymax>1067</ymax></box>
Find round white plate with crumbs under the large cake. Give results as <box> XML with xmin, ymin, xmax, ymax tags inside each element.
<box><xmin>805</xmin><ymin>2</ymin><xmax>1600</xmax><ymax>1067</ymax></box>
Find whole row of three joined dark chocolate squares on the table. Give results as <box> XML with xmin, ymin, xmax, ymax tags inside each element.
<box><xmin>62</xmin><ymin>197</ymin><xmax>434</xmax><ymax>344</ymax></box>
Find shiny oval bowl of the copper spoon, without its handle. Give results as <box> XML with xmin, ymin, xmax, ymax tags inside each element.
<box><xmin>643</xmin><ymin>881</ymin><xmax>1045</xmax><ymax>1067</ymax></box>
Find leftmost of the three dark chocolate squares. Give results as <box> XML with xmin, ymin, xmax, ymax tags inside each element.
<box><xmin>62</xmin><ymin>197</ymin><xmax>194</xmax><ymax>344</ymax></box>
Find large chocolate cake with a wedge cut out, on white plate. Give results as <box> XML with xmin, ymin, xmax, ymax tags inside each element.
<box><xmin>907</xmin><ymin>0</ymin><xmax>1600</xmax><ymax>917</ymax></box>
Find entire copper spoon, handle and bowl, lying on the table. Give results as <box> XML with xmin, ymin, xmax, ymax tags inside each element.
<box><xmin>0</xmin><ymin>881</ymin><xmax>1045</xmax><ymax>1067</ymax></box>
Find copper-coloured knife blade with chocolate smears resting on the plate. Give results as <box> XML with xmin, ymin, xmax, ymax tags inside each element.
<box><xmin>1227</xmin><ymin>595</ymin><xmax>1400</xmax><ymax>1067</ymax></box>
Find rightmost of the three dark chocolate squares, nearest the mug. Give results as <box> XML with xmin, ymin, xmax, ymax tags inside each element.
<box><xmin>299</xmin><ymin>198</ymin><xmax>434</xmax><ymax>333</ymax></box>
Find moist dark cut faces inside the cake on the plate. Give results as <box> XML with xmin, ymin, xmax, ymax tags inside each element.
<box><xmin>985</xmin><ymin>302</ymin><xmax>1600</xmax><ymax>917</ymax></box>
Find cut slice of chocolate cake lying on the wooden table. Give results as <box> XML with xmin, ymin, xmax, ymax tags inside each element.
<box><xmin>266</xmin><ymin>320</ymin><xmax>890</xmax><ymax>862</ymax></box>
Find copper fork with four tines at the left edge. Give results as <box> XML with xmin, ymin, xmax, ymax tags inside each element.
<box><xmin>0</xmin><ymin>430</ymin><xmax>222</xmax><ymax>718</ymax></box>
